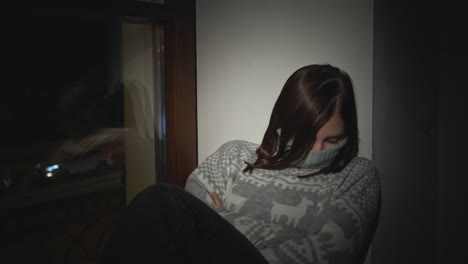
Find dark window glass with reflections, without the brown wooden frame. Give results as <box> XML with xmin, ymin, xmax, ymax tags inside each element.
<box><xmin>0</xmin><ymin>15</ymin><xmax>164</xmax><ymax>203</ymax></box>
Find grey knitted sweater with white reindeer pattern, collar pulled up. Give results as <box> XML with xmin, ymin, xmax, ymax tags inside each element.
<box><xmin>185</xmin><ymin>140</ymin><xmax>380</xmax><ymax>264</ymax></box>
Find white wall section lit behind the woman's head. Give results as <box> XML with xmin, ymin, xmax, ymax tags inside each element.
<box><xmin>196</xmin><ymin>0</ymin><xmax>373</xmax><ymax>162</ymax></box>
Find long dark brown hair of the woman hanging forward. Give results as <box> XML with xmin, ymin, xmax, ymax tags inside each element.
<box><xmin>244</xmin><ymin>64</ymin><xmax>359</xmax><ymax>177</ymax></box>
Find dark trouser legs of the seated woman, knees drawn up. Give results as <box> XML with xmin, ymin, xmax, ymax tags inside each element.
<box><xmin>101</xmin><ymin>184</ymin><xmax>267</xmax><ymax>263</ymax></box>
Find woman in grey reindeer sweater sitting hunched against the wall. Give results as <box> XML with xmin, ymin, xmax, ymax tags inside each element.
<box><xmin>103</xmin><ymin>65</ymin><xmax>380</xmax><ymax>264</ymax></box>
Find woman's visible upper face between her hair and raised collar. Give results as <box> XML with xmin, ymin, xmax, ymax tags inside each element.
<box><xmin>311</xmin><ymin>113</ymin><xmax>345</xmax><ymax>151</ymax></box>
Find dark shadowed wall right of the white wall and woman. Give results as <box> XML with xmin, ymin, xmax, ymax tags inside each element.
<box><xmin>372</xmin><ymin>0</ymin><xmax>468</xmax><ymax>264</ymax></box>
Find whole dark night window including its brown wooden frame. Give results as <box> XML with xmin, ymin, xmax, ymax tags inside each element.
<box><xmin>0</xmin><ymin>1</ymin><xmax>196</xmax><ymax>204</ymax></box>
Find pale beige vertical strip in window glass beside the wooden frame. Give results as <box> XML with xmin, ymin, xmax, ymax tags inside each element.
<box><xmin>121</xmin><ymin>22</ymin><xmax>165</xmax><ymax>201</ymax></box>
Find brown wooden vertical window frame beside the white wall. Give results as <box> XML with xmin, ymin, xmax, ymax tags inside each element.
<box><xmin>165</xmin><ymin>0</ymin><xmax>197</xmax><ymax>187</ymax></box>
